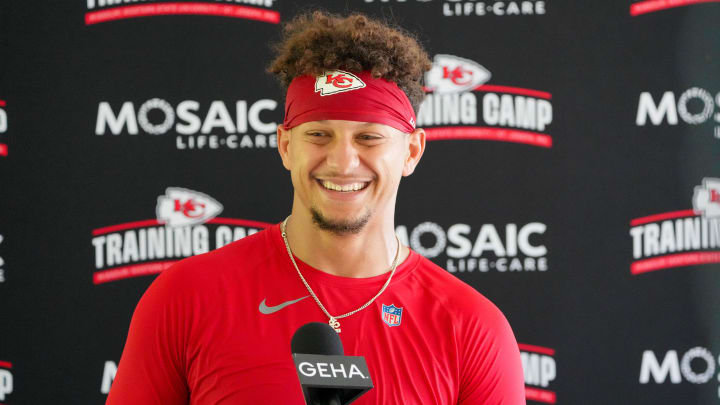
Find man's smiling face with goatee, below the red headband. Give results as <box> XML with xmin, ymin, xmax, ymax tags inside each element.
<box><xmin>278</xmin><ymin>120</ymin><xmax>425</xmax><ymax>234</ymax></box>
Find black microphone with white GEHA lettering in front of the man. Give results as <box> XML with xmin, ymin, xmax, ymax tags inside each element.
<box><xmin>290</xmin><ymin>322</ymin><xmax>373</xmax><ymax>405</ymax></box>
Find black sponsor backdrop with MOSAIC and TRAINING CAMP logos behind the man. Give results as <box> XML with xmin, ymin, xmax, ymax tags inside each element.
<box><xmin>0</xmin><ymin>0</ymin><xmax>720</xmax><ymax>405</ymax></box>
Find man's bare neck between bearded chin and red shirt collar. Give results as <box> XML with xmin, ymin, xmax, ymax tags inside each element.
<box><xmin>286</xmin><ymin>204</ymin><xmax>409</xmax><ymax>278</ymax></box>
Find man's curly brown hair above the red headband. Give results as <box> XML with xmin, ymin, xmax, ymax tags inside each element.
<box><xmin>267</xmin><ymin>11</ymin><xmax>432</xmax><ymax>113</ymax></box>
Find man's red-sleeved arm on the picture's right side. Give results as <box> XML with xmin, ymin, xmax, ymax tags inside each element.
<box><xmin>458</xmin><ymin>300</ymin><xmax>525</xmax><ymax>405</ymax></box>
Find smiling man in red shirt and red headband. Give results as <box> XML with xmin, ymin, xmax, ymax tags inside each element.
<box><xmin>107</xmin><ymin>13</ymin><xmax>525</xmax><ymax>405</ymax></box>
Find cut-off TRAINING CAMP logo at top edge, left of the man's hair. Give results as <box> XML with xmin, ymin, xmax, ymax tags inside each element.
<box><xmin>85</xmin><ymin>0</ymin><xmax>280</xmax><ymax>25</ymax></box>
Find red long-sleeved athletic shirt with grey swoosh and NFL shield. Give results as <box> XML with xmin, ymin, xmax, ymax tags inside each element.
<box><xmin>106</xmin><ymin>225</ymin><xmax>525</xmax><ymax>405</ymax></box>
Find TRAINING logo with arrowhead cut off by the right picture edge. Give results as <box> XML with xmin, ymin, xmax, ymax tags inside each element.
<box><xmin>630</xmin><ymin>177</ymin><xmax>720</xmax><ymax>275</ymax></box>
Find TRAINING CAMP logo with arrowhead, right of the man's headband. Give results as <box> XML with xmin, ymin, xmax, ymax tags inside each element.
<box><xmin>417</xmin><ymin>53</ymin><xmax>553</xmax><ymax>148</ymax></box>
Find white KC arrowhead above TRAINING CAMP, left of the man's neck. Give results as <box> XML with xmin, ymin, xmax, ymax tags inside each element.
<box><xmin>155</xmin><ymin>187</ymin><xmax>223</xmax><ymax>226</ymax></box>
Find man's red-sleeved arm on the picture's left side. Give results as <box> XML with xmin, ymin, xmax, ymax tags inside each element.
<box><xmin>106</xmin><ymin>268</ymin><xmax>189</xmax><ymax>405</ymax></box>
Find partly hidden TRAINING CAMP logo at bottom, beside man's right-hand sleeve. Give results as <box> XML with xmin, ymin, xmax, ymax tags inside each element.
<box><xmin>518</xmin><ymin>343</ymin><xmax>557</xmax><ymax>404</ymax></box>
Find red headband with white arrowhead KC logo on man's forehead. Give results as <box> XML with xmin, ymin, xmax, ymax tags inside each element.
<box><xmin>283</xmin><ymin>70</ymin><xmax>415</xmax><ymax>133</ymax></box>
